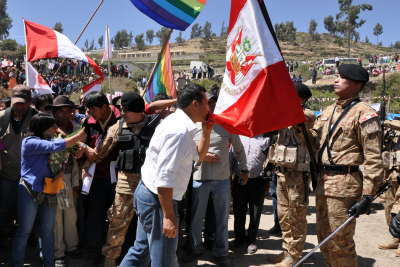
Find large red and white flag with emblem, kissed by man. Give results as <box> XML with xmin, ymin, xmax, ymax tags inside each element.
<box><xmin>214</xmin><ymin>0</ymin><xmax>306</xmax><ymax>137</ymax></box>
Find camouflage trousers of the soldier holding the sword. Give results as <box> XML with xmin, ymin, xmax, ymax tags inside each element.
<box><xmin>316</xmin><ymin>194</ymin><xmax>358</xmax><ymax>267</ymax></box>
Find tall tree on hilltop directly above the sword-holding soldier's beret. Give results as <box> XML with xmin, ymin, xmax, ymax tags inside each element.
<box><xmin>336</xmin><ymin>0</ymin><xmax>372</xmax><ymax>57</ymax></box>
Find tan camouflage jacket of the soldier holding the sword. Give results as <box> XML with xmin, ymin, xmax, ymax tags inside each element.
<box><xmin>311</xmin><ymin>95</ymin><xmax>383</xmax><ymax>197</ymax></box>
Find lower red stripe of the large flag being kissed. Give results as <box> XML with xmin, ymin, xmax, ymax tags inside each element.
<box><xmin>214</xmin><ymin>61</ymin><xmax>306</xmax><ymax>137</ymax></box>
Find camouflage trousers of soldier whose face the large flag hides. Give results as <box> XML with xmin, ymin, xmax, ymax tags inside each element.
<box><xmin>276</xmin><ymin>171</ymin><xmax>310</xmax><ymax>259</ymax></box>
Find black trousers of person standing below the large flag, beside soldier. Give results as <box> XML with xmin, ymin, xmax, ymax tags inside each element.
<box><xmin>232</xmin><ymin>176</ymin><xmax>264</xmax><ymax>244</ymax></box>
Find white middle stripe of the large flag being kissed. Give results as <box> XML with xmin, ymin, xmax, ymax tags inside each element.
<box><xmin>215</xmin><ymin>0</ymin><xmax>283</xmax><ymax>114</ymax></box>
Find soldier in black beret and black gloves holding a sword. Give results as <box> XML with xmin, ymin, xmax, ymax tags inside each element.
<box><xmin>302</xmin><ymin>64</ymin><xmax>383</xmax><ymax>267</ymax></box>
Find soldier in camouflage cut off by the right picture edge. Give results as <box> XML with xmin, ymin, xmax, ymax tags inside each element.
<box><xmin>379</xmin><ymin>120</ymin><xmax>400</xmax><ymax>253</ymax></box>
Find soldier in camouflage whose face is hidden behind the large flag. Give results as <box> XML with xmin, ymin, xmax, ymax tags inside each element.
<box><xmin>268</xmin><ymin>82</ymin><xmax>316</xmax><ymax>267</ymax></box>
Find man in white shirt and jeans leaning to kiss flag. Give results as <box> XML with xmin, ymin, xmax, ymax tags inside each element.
<box><xmin>120</xmin><ymin>84</ymin><xmax>214</xmax><ymax>267</ymax></box>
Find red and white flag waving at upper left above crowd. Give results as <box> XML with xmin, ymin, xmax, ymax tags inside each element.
<box><xmin>24</xmin><ymin>20</ymin><xmax>104</xmax><ymax>81</ymax></box>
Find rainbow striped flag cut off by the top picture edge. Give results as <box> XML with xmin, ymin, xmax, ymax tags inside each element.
<box><xmin>131</xmin><ymin>0</ymin><xmax>207</xmax><ymax>31</ymax></box>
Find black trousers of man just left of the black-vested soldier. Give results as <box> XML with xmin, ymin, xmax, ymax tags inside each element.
<box><xmin>86</xmin><ymin>177</ymin><xmax>116</xmax><ymax>257</ymax></box>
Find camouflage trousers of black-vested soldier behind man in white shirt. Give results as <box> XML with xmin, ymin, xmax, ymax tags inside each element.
<box><xmin>102</xmin><ymin>192</ymin><xmax>135</xmax><ymax>258</ymax></box>
